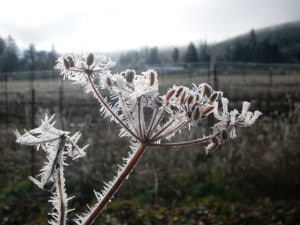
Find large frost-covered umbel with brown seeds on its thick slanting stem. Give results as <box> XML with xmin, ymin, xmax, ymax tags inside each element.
<box><xmin>55</xmin><ymin>53</ymin><xmax>261</xmax><ymax>224</ymax></box>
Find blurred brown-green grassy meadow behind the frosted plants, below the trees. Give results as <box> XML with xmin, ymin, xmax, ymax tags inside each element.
<box><xmin>0</xmin><ymin>73</ymin><xmax>300</xmax><ymax>225</ymax></box>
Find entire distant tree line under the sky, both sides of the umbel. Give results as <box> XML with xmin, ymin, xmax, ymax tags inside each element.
<box><xmin>0</xmin><ymin>25</ymin><xmax>300</xmax><ymax>72</ymax></box>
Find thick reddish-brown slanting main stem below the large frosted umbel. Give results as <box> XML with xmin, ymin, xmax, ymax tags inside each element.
<box><xmin>83</xmin><ymin>143</ymin><xmax>148</xmax><ymax>225</ymax></box>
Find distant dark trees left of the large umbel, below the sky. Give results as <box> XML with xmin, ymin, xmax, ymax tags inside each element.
<box><xmin>0</xmin><ymin>36</ymin><xmax>58</xmax><ymax>72</ymax></box>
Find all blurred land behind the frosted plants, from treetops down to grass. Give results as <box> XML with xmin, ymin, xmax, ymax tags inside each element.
<box><xmin>0</xmin><ymin>22</ymin><xmax>300</xmax><ymax>225</ymax></box>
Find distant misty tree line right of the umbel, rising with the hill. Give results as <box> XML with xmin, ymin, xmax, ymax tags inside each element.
<box><xmin>119</xmin><ymin>26</ymin><xmax>300</xmax><ymax>66</ymax></box>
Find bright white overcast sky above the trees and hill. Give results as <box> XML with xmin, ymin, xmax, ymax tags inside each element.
<box><xmin>0</xmin><ymin>0</ymin><xmax>300</xmax><ymax>53</ymax></box>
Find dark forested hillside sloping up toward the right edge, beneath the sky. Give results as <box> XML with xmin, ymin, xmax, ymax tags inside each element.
<box><xmin>211</xmin><ymin>21</ymin><xmax>300</xmax><ymax>63</ymax></box>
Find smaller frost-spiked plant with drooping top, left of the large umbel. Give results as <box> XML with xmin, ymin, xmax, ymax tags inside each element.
<box><xmin>15</xmin><ymin>115</ymin><xmax>88</xmax><ymax>225</ymax></box>
